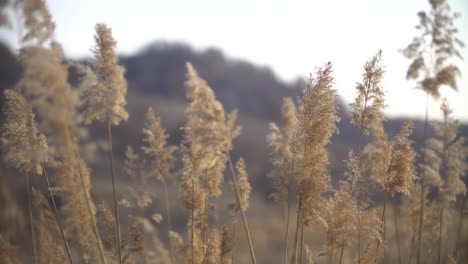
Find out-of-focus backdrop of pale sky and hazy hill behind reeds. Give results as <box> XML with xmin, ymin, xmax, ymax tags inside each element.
<box><xmin>0</xmin><ymin>0</ymin><xmax>468</xmax><ymax>263</ymax></box>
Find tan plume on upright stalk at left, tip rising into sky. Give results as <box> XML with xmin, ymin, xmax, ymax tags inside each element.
<box><xmin>82</xmin><ymin>24</ymin><xmax>128</xmax><ymax>125</ymax></box>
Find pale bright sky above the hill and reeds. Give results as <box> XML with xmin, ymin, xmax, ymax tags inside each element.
<box><xmin>0</xmin><ymin>0</ymin><xmax>468</xmax><ymax>121</ymax></box>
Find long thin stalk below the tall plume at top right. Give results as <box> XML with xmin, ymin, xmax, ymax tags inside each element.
<box><xmin>417</xmin><ymin>93</ymin><xmax>429</xmax><ymax>264</ymax></box>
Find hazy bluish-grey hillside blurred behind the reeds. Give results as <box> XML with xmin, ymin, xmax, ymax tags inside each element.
<box><xmin>0</xmin><ymin>42</ymin><xmax>468</xmax><ymax>198</ymax></box>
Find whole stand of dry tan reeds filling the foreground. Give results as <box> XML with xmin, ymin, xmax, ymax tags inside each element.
<box><xmin>0</xmin><ymin>0</ymin><xmax>468</xmax><ymax>264</ymax></box>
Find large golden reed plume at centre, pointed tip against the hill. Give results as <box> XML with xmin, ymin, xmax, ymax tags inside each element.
<box><xmin>181</xmin><ymin>63</ymin><xmax>245</xmax><ymax>260</ymax></box>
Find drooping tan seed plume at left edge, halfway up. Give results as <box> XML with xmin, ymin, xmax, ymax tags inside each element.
<box><xmin>1</xmin><ymin>89</ymin><xmax>47</xmax><ymax>174</ymax></box>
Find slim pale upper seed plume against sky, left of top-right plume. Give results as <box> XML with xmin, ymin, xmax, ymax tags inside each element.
<box><xmin>351</xmin><ymin>51</ymin><xmax>385</xmax><ymax>137</ymax></box>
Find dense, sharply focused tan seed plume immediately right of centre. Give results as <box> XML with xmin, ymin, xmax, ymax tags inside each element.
<box><xmin>294</xmin><ymin>63</ymin><xmax>339</xmax><ymax>224</ymax></box>
